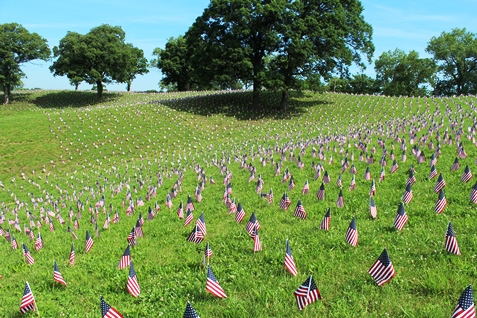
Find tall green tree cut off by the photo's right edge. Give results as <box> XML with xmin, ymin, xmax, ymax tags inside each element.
<box><xmin>426</xmin><ymin>28</ymin><xmax>477</xmax><ymax>96</ymax></box>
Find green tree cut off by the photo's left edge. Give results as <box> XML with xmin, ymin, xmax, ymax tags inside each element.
<box><xmin>0</xmin><ymin>23</ymin><xmax>51</xmax><ymax>104</ymax></box>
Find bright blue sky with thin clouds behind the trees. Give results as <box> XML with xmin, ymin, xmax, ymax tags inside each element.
<box><xmin>0</xmin><ymin>0</ymin><xmax>477</xmax><ymax>91</ymax></box>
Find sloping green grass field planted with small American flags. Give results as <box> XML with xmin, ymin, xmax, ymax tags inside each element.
<box><xmin>0</xmin><ymin>91</ymin><xmax>477</xmax><ymax>317</ymax></box>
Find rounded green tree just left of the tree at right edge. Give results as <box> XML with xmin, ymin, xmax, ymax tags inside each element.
<box><xmin>374</xmin><ymin>49</ymin><xmax>436</xmax><ymax>96</ymax></box>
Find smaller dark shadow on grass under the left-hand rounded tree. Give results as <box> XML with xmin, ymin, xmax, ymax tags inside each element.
<box><xmin>31</xmin><ymin>91</ymin><xmax>120</xmax><ymax>108</ymax></box>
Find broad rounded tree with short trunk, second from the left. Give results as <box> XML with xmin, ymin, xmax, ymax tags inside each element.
<box><xmin>50</xmin><ymin>24</ymin><xmax>148</xmax><ymax>99</ymax></box>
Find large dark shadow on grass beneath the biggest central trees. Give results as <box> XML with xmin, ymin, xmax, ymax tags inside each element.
<box><xmin>151</xmin><ymin>92</ymin><xmax>329</xmax><ymax>120</ymax></box>
